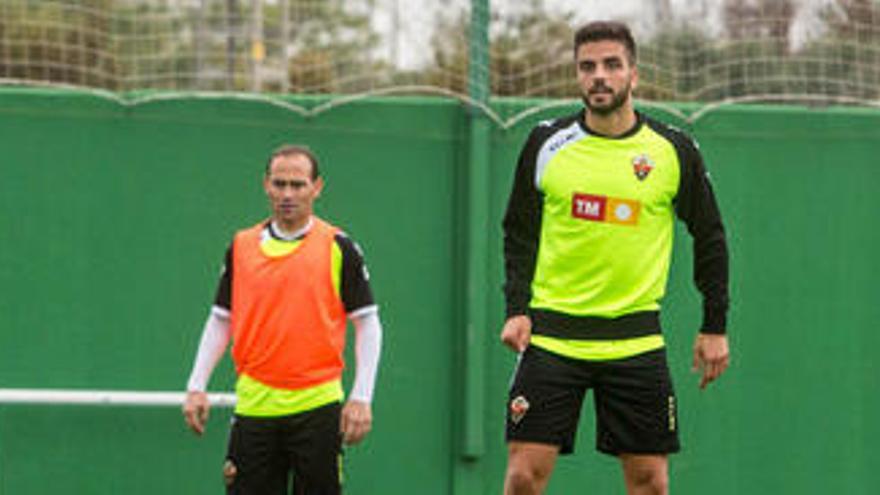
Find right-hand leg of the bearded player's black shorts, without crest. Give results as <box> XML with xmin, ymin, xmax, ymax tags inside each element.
<box><xmin>594</xmin><ymin>349</ymin><xmax>679</xmax><ymax>455</ymax></box>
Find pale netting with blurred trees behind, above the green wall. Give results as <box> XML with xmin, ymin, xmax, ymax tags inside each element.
<box><xmin>0</xmin><ymin>0</ymin><xmax>880</xmax><ymax>121</ymax></box>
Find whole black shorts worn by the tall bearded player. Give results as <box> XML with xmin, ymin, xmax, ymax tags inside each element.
<box><xmin>506</xmin><ymin>346</ymin><xmax>679</xmax><ymax>455</ymax></box>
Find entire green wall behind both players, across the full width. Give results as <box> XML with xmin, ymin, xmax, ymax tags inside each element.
<box><xmin>0</xmin><ymin>89</ymin><xmax>880</xmax><ymax>495</ymax></box>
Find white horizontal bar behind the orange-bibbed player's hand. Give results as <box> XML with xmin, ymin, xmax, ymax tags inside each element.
<box><xmin>0</xmin><ymin>388</ymin><xmax>235</xmax><ymax>407</ymax></box>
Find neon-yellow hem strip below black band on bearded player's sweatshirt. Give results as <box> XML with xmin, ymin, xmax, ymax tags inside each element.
<box><xmin>531</xmin><ymin>334</ymin><xmax>666</xmax><ymax>361</ymax></box>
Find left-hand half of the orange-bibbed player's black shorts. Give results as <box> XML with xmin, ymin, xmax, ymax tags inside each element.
<box><xmin>223</xmin><ymin>416</ymin><xmax>289</xmax><ymax>495</ymax></box>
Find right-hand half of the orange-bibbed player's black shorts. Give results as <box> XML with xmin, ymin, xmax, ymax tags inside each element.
<box><xmin>285</xmin><ymin>402</ymin><xmax>342</xmax><ymax>495</ymax></box>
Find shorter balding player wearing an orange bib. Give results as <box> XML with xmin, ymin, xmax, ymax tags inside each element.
<box><xmin>183</xmin><ymin>145</ymin><xmax>382</xmax><ymax>495</ymax></box>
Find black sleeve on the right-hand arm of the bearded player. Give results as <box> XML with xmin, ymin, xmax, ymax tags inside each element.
<box><xmin>675</xmin><ymin>134</ymin><xmax>729</xmax><ymax>333</ymax></box>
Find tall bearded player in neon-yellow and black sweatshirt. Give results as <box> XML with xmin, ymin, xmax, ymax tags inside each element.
<box><xmin>501</xmin><ymin>22</ymin><xmax>729</xmax><ymax>495</ymax></box>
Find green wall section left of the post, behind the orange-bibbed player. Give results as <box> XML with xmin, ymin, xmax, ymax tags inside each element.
<box><xmin>0</xmin><ymin>91</ymin><xmax>465</xmax><ymax>494</ymax></box>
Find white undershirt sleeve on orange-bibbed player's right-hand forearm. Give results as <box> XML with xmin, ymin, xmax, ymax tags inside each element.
<box><xmin>349</xmin><ymin>311</ymin><xmax>382</xmax><ymax>403</ymax></box>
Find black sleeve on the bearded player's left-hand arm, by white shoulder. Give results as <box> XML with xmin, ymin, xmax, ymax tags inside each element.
<box><xmin>502</xmin><ymin>127</ymin><xmax>545</xmax><ymax>318</ymax></box>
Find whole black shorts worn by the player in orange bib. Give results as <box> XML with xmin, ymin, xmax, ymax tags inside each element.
<box><xmin>224</xmin><ymin>402</ymin><xmax>342</xmax><ymax>495</ymax></box>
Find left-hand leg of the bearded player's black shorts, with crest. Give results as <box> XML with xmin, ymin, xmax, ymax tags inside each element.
<box><xmin>506</xmin><ymin>346</ymin><xmax>589</xmax><ymax>454</ymax></box>
